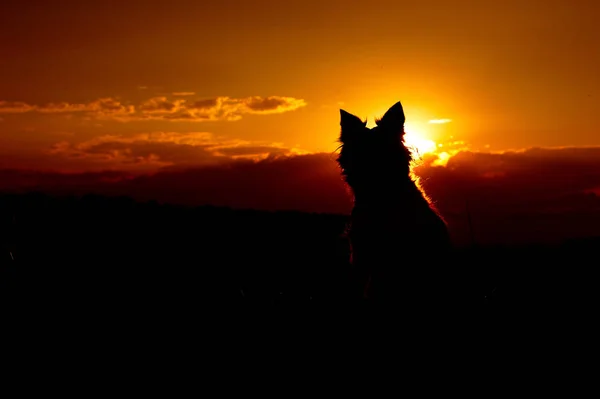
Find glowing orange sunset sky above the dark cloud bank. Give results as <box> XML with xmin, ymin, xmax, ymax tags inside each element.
<box><xmin>0</xmin><ymin>0</ymin><xmax>600</xmax><ymax>171</ymax></box>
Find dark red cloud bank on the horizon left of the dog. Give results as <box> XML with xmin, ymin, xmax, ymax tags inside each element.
<box><xmin>0</xmin><ymin>154</ymin><xmax>352</xmax><ymax>213</ymax></box>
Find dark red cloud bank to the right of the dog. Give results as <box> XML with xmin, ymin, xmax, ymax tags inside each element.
<box><xmin>415</xmin><ymin>147</ymin><xmax>600</xmax><ymax>247</ymax></box>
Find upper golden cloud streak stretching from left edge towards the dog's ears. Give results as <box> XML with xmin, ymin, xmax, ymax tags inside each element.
<box><xmin>0</xmin><ymin>92</ymin><xmax>306</xmax><ymax>122</ymax></box>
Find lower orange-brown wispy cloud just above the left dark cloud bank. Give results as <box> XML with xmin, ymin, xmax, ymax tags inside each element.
<box><xmin>47</xmin><ymin>131</ymin><xmax>308</xmax><ymax>170</ymax></box>
